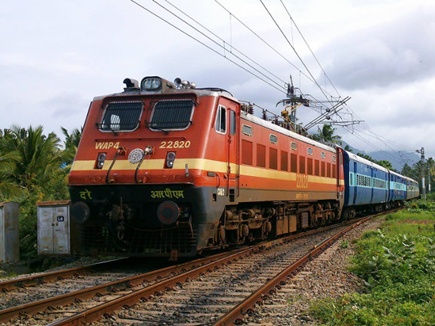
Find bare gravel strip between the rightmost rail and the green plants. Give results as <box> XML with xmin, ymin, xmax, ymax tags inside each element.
<box><xmin>244</xmin><ymin>218</ymin><xmax>383</xmax><ymax>325</ymax></box>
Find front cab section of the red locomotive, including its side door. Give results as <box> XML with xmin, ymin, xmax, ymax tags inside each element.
<box><xmin>69</xmin><ymin>76</ymin><xmax>244</xmax><ymax>256</ymax></box>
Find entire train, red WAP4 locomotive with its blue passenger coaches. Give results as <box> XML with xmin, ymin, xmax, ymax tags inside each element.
<box><xmin>68</xmin><ymin>76</ymin><xmax>419</xmax><ymax>259</ymax></box>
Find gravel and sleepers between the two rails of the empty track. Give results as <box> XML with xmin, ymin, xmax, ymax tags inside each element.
<box><xmin>94</xmin><ymin>227</ymin><xmax>354</xmax><ymax>325</ymax></box>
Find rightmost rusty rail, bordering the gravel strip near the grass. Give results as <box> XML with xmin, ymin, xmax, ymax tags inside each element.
<box><xmin>215</xmin><ymin>213</ymin><xmax>374</xmax><ymax>326</ymax></box>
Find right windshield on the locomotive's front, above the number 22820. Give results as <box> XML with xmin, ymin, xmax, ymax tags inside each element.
<box><xmin>149</xmin><ymin>100</ymin><xmax>194</xmax><ymax>130</ymax></box>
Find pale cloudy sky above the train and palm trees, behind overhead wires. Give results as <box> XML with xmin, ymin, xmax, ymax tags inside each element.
<box><xmin>0</xmin><ymin>0</ymin><xmax>435</xmax><ymax>159</ymax></box>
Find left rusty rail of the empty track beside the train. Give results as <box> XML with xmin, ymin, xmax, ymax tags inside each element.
<box><xmin>45</xmin><ymin>220</ymin><xmax>350</xmax><ymax>326</ymax></box>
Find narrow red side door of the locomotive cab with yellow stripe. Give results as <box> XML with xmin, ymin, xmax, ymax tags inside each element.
<box><xmin>227</xmin><ymin>108</ymin><xmax>240</xmax><ymax>202</ymax></box>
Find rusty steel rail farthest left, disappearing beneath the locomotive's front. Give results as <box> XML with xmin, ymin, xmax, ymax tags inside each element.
<box><xmin>0</xmin><ymin>257</ymin><xmax>128</xmax><ymax>292</ymax></box>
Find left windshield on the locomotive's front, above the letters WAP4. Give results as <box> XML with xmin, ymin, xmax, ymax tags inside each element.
<box><xmin>98</xmin><ymin>102</ymin><xmax>142</xmax><ymax>131</ymax></box>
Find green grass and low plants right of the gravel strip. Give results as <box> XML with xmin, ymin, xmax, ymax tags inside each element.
<box><xmin>310</xmin><ymin>194</ymin><xmax>435</xmax><ymax>325</ymax></box>
